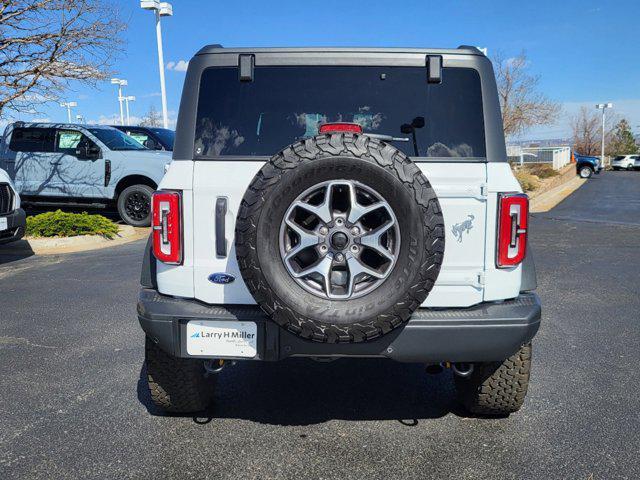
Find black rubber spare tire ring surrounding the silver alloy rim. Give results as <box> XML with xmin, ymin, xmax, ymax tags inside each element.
<box><xmin>236</xmin><ymin>133</ymin><xmax>445</xmax><ymax>343</ymax></box>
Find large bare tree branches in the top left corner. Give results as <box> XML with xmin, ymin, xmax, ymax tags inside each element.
<box><xmin>0</xmin><ymin>0</ymin><xmax>124</xmax><ymax>116</ymax></box>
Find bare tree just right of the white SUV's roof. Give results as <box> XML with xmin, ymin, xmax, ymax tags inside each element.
<box><xmin>493</xmin><ymin>52</ymin><xmax>560</xmax><ymax>136</ymax></box>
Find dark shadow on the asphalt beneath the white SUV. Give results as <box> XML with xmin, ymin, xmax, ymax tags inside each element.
<box><xmin>138</xmin><ymin>359</ymin><xmax>466</xmax><ymax>426</ymax></box>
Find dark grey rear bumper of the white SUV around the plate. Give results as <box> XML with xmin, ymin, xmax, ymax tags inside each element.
<box><xmin>138</xmin><ymin>289</ymin><xmax>541</xmax><ymax>363</ymax></box>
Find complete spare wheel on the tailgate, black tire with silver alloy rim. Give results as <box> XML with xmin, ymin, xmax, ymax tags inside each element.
<box><xmin>236</xmin><ymin>133</ymin><xmax>444</xmax><ymax>343</ymax></box>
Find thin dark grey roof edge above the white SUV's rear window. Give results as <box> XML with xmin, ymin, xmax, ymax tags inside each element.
<box><xmin>196</xmin><ymin>43</ymin><xmax>484</xmax><ymax>56</ymax></box>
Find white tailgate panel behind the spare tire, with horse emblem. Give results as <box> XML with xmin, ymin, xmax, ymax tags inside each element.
<box><xmin>193</xmin><ymin>160</ymin><xmax>487</xmax><ymax>307</ymax></box>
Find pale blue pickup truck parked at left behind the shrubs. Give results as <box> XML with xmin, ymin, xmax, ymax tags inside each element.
<box><xmin>0</xmin><ymin>122</ymin><xmax>171</xmax><ymax>226</ymax></box>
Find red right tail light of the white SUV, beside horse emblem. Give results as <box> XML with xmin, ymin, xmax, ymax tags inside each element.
<box><xmin>496</xmin><ymin>193</ymin><xmax>529</xmax><ymax>268</ymax></box>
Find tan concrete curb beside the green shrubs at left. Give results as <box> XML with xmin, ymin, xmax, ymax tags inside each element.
<box><xmin>0</xmin><ymin>225</ymin><xmax>150</xmax><ymax>255</ymax></box>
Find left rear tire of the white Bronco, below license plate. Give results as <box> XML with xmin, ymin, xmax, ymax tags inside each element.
<box><xmin>145</xmin><ymin>337</ymin><xmax>216</xmax><ymax>413</ymax></box>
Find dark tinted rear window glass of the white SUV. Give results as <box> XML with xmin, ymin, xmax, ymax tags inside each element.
<box><xmin>195</xmin><ymin>66</ymin><xmax>486</xmax><ymax>157</ymax></box>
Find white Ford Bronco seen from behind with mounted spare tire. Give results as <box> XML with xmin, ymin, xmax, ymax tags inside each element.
<box><xmin>138</xmin><ymin>45</ymin><xmax>541</xmax><ymax>415</ymax></box>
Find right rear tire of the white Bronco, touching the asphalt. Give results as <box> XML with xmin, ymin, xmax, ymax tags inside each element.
<box><xmin>455</xmin><ymin>343</ymin><xmax>531</xmax><ymax>415</ymax></box>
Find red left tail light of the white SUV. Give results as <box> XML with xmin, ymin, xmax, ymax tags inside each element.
<box><xmin>151</xmin><ymin>190</ymin><xmax>182</xmax><ymax>265</ymax></box>
